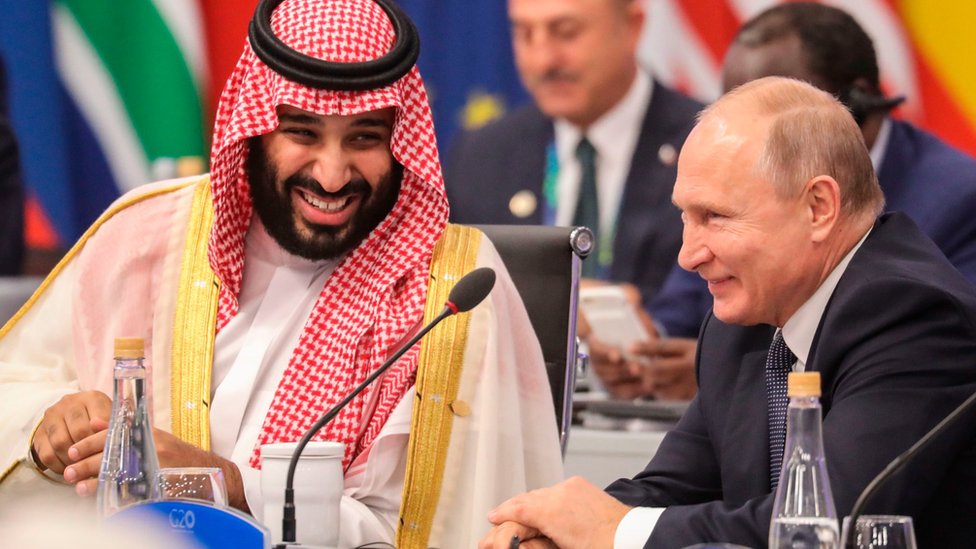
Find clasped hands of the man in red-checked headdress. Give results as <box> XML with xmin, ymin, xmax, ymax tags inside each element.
<box><xmin>31</xmin><ymin>391</ymin><xmax>247</xmax><ymax>511</ymax></box>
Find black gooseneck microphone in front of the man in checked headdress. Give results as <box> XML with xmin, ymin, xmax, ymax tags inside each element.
<box><xmin>275</xmin><ymin>267</ymin><xmax>495</xmax><ymax>549</ymax></box>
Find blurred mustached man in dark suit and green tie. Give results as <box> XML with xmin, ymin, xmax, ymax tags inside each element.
<box><xmin>445</xmin><ymin>0</ymin><xmax>701</xmax><ymax>304</ymax></box>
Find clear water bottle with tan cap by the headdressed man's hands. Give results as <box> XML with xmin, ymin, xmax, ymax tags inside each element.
<box><xmin>97</xmin><ymin>337</ymin><xmax>159</xmax><ymax>517</ymax></box>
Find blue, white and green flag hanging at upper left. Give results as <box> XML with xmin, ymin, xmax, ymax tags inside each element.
<box><xmin>0</xmin><ymin>0</ymin><xmax>207</xmax><ymax>248</ymax></box>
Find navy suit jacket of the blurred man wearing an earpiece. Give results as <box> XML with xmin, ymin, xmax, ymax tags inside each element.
<box><xmin>649</xmin><ymin>120</ymin><xmax>976</xmax><ymax>337</ymax></box>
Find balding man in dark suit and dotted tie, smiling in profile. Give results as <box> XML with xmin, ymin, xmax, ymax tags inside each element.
<box><xmin>482</xmin><ymin>77</ymin><xmax>976</xmax><ymax>549</ymax></box>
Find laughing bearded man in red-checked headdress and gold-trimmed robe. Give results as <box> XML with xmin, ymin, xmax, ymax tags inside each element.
<box><xmin>0</xmin><ymin>0</ymin><xmax>562</xmax><ymax>548</ymax></box>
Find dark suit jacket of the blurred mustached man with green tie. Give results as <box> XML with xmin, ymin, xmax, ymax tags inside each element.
<box><xmin>444</xmin><ymin>82</ymin><xmax>702</xmax><ymax>304</ymax></box>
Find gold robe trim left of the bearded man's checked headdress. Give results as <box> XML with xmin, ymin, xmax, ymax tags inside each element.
<box><xmin>171</xmin><ymin>179</ymin><xmax>220</xmax><ymax>450</ymax></box>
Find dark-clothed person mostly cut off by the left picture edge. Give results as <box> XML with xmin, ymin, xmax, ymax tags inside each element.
<box><xmin>0</xmin><ymin>59</ymin><xmax>24</xmax><ymax>275</ymax></box>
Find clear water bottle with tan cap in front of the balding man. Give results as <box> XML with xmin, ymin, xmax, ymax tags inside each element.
<box><xmin>769</xmin><ymin>372</ymin><xmax>840</xmax><ymax>549</ymax></box>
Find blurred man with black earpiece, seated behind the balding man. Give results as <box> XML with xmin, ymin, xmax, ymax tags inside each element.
<box><xmin>591</xmin><ymin>2</ymin><xmax>976</xmax><ymax>398</ymax></box>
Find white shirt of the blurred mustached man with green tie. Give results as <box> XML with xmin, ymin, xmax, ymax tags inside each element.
<box><xmin>554</xmin><ymin>68</ymin><xmax>653</xmax><ymax>232</ymax></box>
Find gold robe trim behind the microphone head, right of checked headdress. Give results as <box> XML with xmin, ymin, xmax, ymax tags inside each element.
<box><xmin>396</xmin><ymin>225</ymin><xmax>481</xmax><ymax>549</ymax></box>
